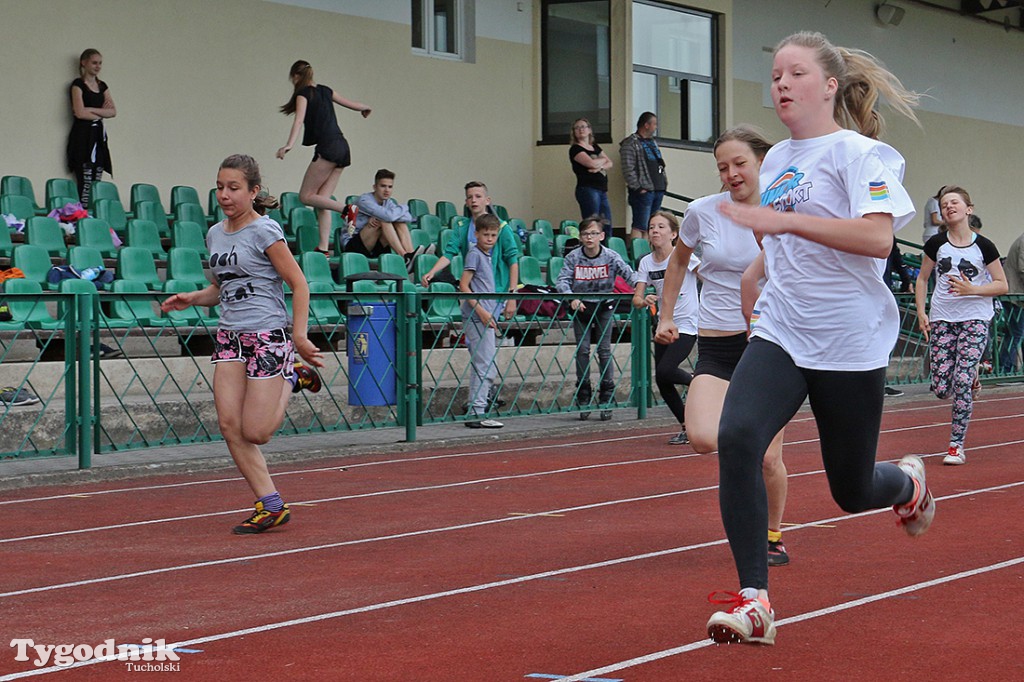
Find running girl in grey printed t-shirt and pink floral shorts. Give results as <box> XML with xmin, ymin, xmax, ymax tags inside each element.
<box><xmin>161</xmin><ymin>155</ymin><xmax>324</xmax><ymax>535</ymax></box>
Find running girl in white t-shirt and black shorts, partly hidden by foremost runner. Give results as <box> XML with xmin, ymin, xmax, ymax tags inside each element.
<box><xmin>655</xmin><ymin>126</ymin><xmax>790</xmax><ymax>566</ymax></box>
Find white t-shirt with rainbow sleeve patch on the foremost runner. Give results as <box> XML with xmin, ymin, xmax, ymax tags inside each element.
<box><xmin>753</xmin><ymin>130</ymin><xmax>914</xmax><ymax>372</ymax></box>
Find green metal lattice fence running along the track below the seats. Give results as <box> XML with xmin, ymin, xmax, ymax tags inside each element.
<box><xmin>0</xmin><ymin>283</ymin><xmax>1024</xmax><ymax>468</ymax></box>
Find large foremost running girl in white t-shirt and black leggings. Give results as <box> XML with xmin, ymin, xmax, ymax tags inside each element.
<box><xmin>708</xmin><ymin>32</ymin><xmax>935</xmax><ymax>644</ymax></box>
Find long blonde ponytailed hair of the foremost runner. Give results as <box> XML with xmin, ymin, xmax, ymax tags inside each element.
<box><xmin>775</xmin><ymin>31</ymin><xmax>921</xmax><ymax>139</ymax></box>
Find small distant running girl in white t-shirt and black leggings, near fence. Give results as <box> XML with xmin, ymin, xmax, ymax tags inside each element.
<box><xmin>633</xmin><ymin>211</ymin><xmax>700</xmax><ymax>445</ymax></box>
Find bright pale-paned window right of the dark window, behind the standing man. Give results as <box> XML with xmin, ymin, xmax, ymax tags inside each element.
<box><xmin>633</xmin><ymin>0</ymin><xmax>719</xmax><ymax>147</ymax></box>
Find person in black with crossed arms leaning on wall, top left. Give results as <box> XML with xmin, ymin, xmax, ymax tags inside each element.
<box><xmin>68</xmin><ymin>48</ymin><xmax>118</xmax><ymax>207</ymax></box>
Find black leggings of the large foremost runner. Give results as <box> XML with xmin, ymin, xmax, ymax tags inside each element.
<box><xmin>718</xmin><ymin>338</ymin><xmax>913</xmax><ymax>590</ymax></box>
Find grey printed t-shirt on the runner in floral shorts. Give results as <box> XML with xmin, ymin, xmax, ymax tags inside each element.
<box><xmin>206</xmin><ymin>216</ymin><xmax>290</xmax><ymax>332</ymax></box>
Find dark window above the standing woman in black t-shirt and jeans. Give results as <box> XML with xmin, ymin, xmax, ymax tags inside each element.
<box><xmin>541</xmin><ymin>0</ymin><xmax>611</xmax><ymax>144</ymax></box>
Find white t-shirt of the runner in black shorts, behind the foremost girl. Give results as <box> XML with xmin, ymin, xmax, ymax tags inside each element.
<box><xmin>679</xmin><ymin>191</ymin><xmax>761</xmax><ymax>332</ymax></box>
